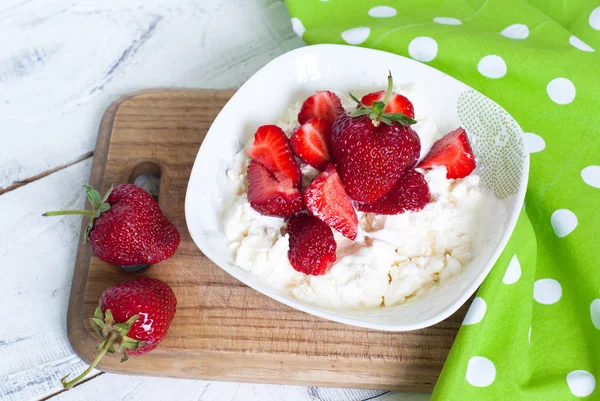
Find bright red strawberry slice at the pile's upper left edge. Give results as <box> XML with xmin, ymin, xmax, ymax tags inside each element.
<box><xmin>248</xmin><ymin>125</ymin><xmax>302</xmax><ymax>188</ymax></box>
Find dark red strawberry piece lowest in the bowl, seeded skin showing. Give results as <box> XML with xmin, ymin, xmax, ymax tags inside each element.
<box><xmin>287</xmin><ymin>214</ymin><xmax>337</xmax><ymax>276</ymax></box>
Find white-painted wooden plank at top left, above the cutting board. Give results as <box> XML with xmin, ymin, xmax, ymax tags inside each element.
<box><xmin>0</xmin><ymin>0</ymin><xmax>303</xmax><ymax>191</ymax></box>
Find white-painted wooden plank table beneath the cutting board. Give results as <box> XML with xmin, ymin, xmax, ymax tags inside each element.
<box><xmin>0</xmin><ymin>0</ymin><xmax>429</xmax><ymax>401</ymax></box>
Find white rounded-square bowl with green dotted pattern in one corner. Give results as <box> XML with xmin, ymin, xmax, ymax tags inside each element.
<box><xmin>185</xmin><ymin>45</ymin><xmax>529</xmax><ymax>331</ymax></box>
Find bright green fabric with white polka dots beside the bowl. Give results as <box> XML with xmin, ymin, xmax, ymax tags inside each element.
<box><xmin>287</xmin><ymin>0</ymin><xmax>600</xmax><ymax>401</ymax></box>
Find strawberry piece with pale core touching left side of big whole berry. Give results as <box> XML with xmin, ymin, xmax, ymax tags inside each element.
<box><xmin>290</xmin><ymin>117</ymin><xmax>331</xmax><ymax>170</ymax></box>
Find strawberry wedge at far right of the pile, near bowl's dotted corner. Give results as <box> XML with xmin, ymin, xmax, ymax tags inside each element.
<box><xmin>418</xmin><ymin>128</ymin><xmax>475</xmax><ymax>178</ymax></box>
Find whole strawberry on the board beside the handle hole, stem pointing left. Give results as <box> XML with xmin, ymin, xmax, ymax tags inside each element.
<box><xmin>44</xmin><ymin>184</ymin><xmax>179</xmax><ymax>271</ymax></box>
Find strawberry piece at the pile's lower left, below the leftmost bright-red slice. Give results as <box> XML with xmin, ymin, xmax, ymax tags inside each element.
<box><xmin>248</xmin><ymin>160</ymin><xmax>303</xmax><ymax>218</ymax></box>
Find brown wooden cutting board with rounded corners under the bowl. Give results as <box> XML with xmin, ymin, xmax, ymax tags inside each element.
<box><xmin>68</xmin><ymin>90</ymin><xmax>466</xmax><ymax>391</ymax></box>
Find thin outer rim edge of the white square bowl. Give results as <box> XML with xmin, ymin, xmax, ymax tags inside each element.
<box><xmin>185</xmin><ymin>44</ymin><xmax>530</xmax><ymax>332</ymax></box>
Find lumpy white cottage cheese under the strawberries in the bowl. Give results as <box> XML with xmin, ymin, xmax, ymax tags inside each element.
<box><xmin>221</xmin><ymin>88</ymin><xmax>506</xmax><ymax>309</ymax></box>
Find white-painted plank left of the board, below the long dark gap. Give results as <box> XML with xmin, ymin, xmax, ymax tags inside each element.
<box><xmin>0</xmin><ymin>158</ymin><xmax>99</xmax><ymax>401</ymax></box>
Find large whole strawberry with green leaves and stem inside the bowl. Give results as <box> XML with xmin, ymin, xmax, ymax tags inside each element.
<box><xmin>331</xmin><ymin>75</ymin><xmax>421</xmax><ymax>203</ymax></box>
